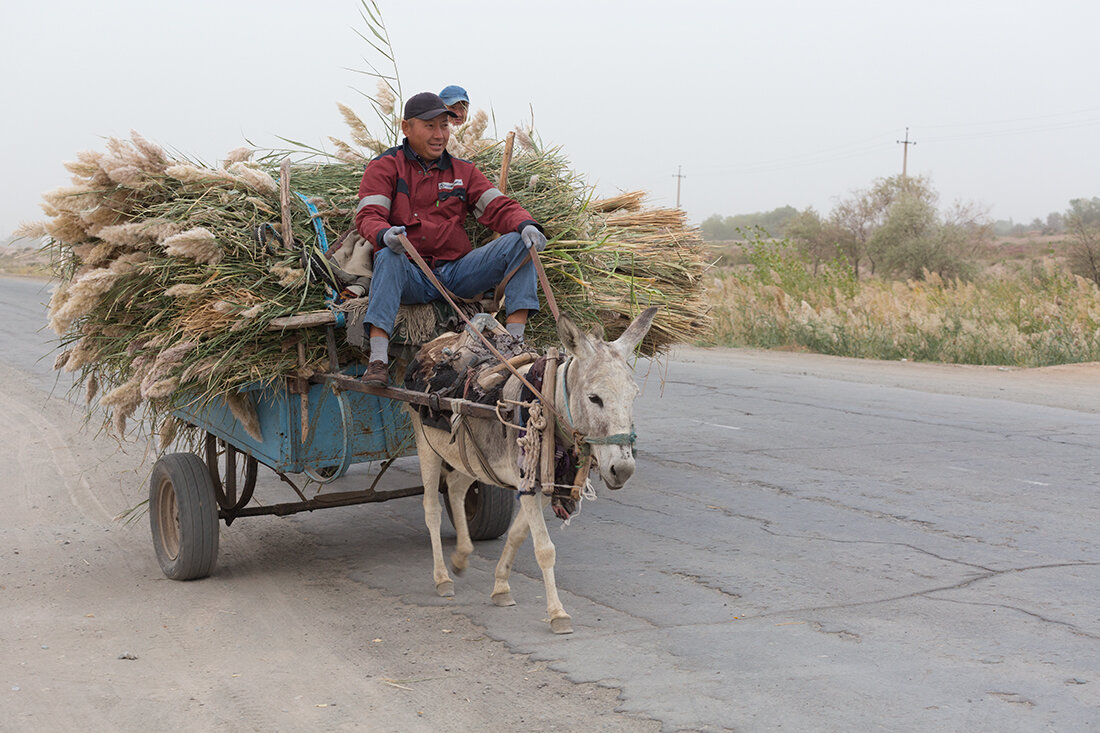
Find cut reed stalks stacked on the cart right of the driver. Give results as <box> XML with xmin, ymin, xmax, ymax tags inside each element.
<box><xmin>451</xmin><ymin>129</ymin><xmax>707</xmax><ymax>354</ymax></box>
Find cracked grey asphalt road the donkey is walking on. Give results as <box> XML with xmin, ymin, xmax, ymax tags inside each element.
<box><xmin>0</xmin><ymin>275</ymin><xmax>1100</xmax><ymax>731</ymax></box>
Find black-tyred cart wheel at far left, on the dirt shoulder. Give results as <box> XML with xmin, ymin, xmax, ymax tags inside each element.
<box><xmin>149</xmin><ymin>453</ymin><xmax>218</xmax><ymax>580</ymax></box>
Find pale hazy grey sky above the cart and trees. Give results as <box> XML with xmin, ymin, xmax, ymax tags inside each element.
<box><xmin>0</xmin><ymin>0</ymin><xmax>1100</xmax><ymax>236</ymax></box>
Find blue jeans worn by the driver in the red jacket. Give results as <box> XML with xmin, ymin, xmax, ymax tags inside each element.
<box><xmin>363</xmin><ymin>232</ymin><xmax>539</xmax><ymax>336</ymax></box>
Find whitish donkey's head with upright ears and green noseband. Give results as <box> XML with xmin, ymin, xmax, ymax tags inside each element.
<box><xmin>558</xmin><ymin>306</ymin><xmax>657</xmax><ymax>489</ymax></box>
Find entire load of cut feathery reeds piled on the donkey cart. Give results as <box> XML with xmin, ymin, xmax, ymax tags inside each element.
<box><xmin>34</xmin><ymin>103</ymin><xmax>705</xmax><ymax>439</ymax></box>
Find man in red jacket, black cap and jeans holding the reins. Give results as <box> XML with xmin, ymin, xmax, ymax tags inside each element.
<box><xmin>355</xmin><ymin>91</ymin><xmax>547</xmax><ymax>386</ymax></box>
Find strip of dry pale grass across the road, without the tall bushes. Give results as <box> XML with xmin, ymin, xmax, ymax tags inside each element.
<box><xmin>704</xmin><ymin>237</ymin><xmax>1100</xmax><ymax>367</ymax></box>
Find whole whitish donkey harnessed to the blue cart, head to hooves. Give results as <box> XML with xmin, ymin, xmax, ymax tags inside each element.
<box><xmin>409</xmin><ymin>307</ymin><xmax>657</xmax><ymax>634</ymax></box>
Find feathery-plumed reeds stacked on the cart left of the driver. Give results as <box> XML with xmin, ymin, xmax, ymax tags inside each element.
<box><xmin>21</xmin><ymin>133</ymin><xmax>343</xmax><ymax>437</ymax></box>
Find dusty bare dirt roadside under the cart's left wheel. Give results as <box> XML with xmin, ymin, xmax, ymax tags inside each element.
<box><xmin>0</xmin><ymin>367</ymin><xmax>660</xmax><ymax>732</ymax></box>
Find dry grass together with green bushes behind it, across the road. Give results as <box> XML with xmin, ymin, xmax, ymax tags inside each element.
<box><xmin>704</xmin><ymin>178</ymin><xmax>1100</xmax><ymax>367</ymax></box>
